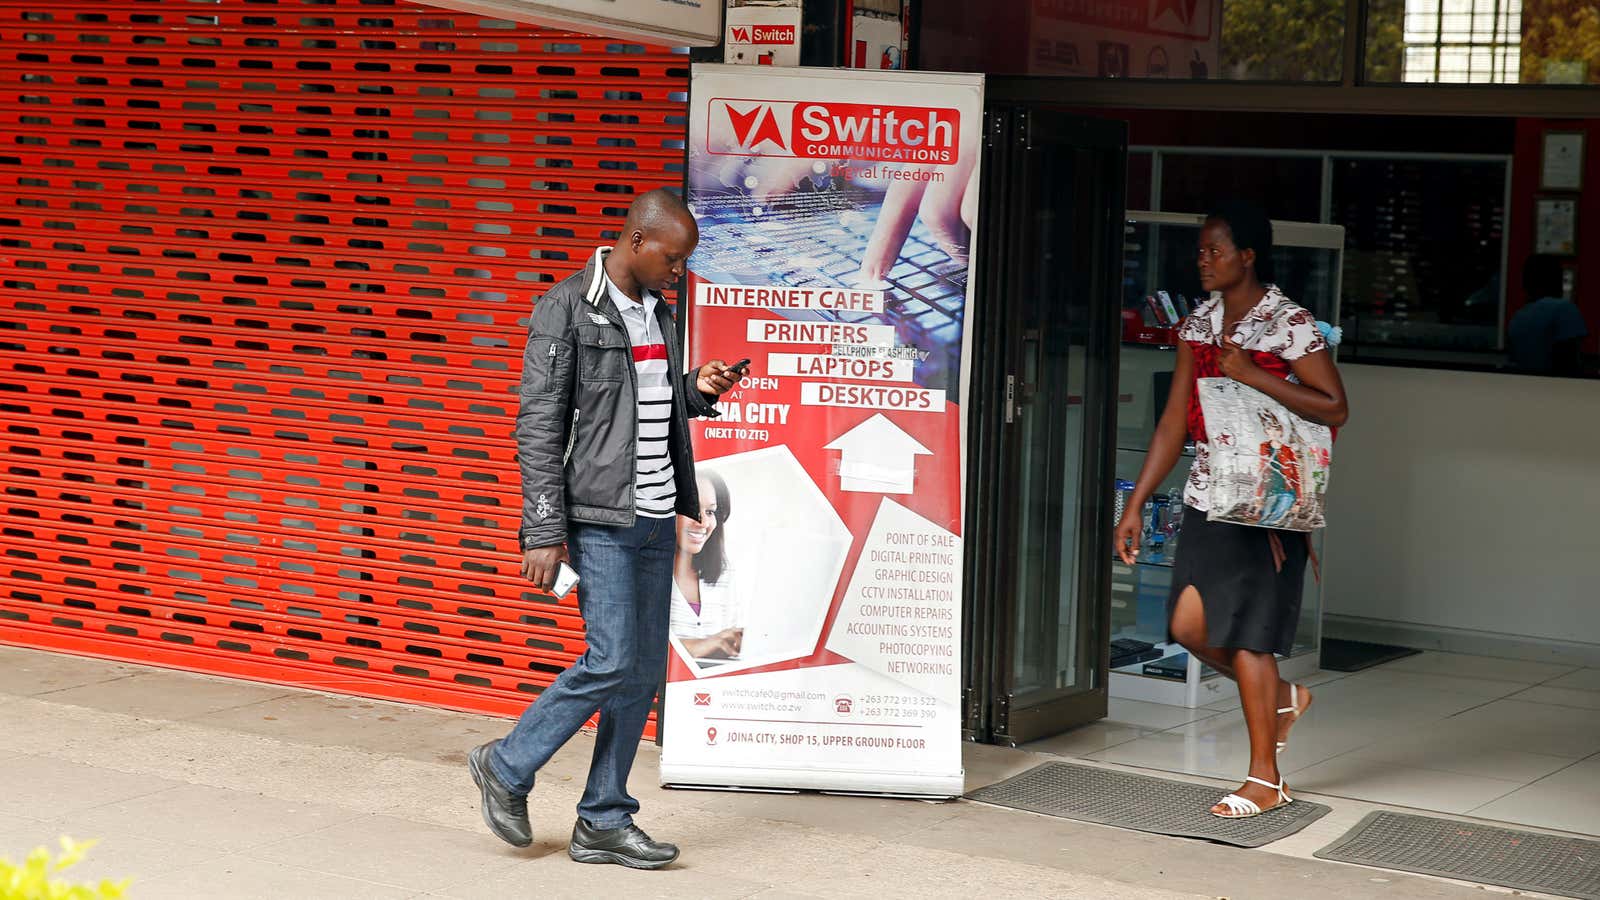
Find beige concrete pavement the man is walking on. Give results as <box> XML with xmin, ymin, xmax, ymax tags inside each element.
<box><xmin>0</xmin><ymin>647</ymin><xmax>1510</xmax><ymax>900</ymax></box>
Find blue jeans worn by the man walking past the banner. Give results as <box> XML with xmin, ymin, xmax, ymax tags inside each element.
<box><xmin>490</xmin><ymin>516</ymin><xmax>678</xmax><ymax>828</ymax></box>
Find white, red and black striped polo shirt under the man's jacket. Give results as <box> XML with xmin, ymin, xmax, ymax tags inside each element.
<box><xmin>600</xmin><ymin>266</ymin><xmax>677</xmax><ymax>519</ymax></box>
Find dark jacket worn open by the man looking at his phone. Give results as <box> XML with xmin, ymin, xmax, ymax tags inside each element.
<box><xmin>517</xmin><ymin>248</ymin><xmax>717</xmax><ymax>549</ymax></box>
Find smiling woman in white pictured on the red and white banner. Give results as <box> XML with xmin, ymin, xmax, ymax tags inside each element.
<box><xmin>672</xmin><ymin>469</ymin><xmax>744</xmax><ymax>660</ymax></box>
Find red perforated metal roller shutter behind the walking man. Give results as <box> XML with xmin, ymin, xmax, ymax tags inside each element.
<box><xmin>0</xmin><ymin>0</ymin><xmax>686</xmax><ymax>713</ymax></box>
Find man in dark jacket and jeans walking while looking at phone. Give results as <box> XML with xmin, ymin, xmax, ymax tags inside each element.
<box><xmin>469</xmin><ymin>191</ymin><xmax>739</xmax><ymax>868</ymax></box>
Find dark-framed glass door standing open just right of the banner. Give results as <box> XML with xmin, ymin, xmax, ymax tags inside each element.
<box><xmin>968</xmin><ymin>104</ymin><xmax>1125</xmax><ymax>743</ymax></box>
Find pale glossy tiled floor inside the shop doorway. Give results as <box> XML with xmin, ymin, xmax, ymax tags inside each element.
<box><xmin>1027</xmin><ymin>653</ymin><xmax>1600</xmax><ymax>834</ymax></box>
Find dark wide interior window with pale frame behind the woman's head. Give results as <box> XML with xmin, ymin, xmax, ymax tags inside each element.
<box><xmin>1130</xmin><ymin>147</ymin><xmax>1510</xmax><ymax>368</ymax></box>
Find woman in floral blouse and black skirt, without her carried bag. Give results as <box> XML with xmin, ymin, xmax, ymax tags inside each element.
<box><xmin>1115</xmin><ymin>205</ymin><xmax>1349</xmax><ymax>818</ymax></box>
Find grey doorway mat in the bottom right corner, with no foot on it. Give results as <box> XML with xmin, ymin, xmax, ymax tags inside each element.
<box><xmin>1312</xmin><ymin>812</ymin><xmax>1600</xmax><ymax>900</ymax></box>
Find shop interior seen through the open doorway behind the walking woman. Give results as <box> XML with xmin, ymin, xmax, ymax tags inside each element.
<box><xmin>915</xmin><ymin>0</ymin><xmax>1600</xmax><ymax>833</ymax></box>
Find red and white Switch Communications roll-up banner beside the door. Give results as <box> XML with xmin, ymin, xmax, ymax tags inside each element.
<box><xmin>661</xmin><ymin>66</ymin><xmax>982</xmax><ymax>796</ymax></box>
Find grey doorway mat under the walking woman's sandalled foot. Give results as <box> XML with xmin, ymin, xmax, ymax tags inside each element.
<box><xmin>966</xmin><ymin>762</ymin><xmax>1328</xmax><ymax>847</ymax></box>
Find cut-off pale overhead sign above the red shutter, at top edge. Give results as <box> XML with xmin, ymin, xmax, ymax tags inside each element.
<box><xmin>412</xmin><ymin>0</ymin><xmax>723</xmax><ymax>46</ymax></box>
